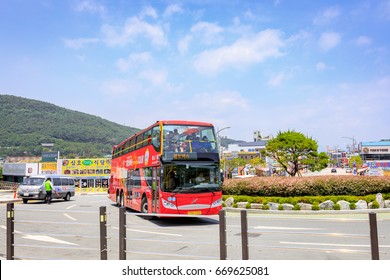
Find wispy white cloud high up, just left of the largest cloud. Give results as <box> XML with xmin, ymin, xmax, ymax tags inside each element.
<box><xmin>102</xmin><ymin>17</ymin><xmax>167</xmax><ymax>46</ymax></box>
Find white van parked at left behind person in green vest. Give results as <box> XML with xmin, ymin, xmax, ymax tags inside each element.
<box><xmin>16</xmin><ymin>175</ymin><xmax>75</xmax><ymax>203</ymax></box>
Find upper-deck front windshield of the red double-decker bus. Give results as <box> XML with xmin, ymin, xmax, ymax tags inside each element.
<box><xmin>163</xmin><ymin>125</ymin><xmax>218</xmax><ymax>153</ymax></box>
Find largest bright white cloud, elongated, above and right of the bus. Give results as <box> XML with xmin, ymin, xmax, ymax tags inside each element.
<box><xmin>194</xmin><ymin>29</ymin><xmax>284</xmax><ymax>74</ymax></box>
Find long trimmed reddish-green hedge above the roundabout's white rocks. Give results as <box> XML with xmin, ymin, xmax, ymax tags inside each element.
<box><xmin>222</xmin><ymin>176</ymin><xmax>390</xmax><ymax>197</ymax></box>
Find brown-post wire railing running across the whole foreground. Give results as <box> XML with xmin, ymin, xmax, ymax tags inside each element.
<box><xmin>6</xmin><ymin>203</ymin><xmax>390</xmax><ymax>260</ymax></box>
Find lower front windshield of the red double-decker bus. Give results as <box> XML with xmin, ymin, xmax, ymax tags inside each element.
<box><xmin>161</xmin><ymin>163</ymin><xmax>220</xmax><ymax>193</ymax></box>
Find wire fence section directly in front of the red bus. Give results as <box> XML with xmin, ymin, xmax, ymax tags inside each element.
<box><xmin>119</xmin><ymin>207</ymin><xmax>226</xmax><ymax>260</ymax></box>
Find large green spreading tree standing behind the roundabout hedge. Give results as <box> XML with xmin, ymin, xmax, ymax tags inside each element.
<box><xmin>262</xmin><ymin>130</ymin><xmax>328</xmax><ymax>176</ymax></box>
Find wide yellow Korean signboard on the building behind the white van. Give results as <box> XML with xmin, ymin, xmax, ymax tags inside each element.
<box><xmin>62</xmin><ymin>158</ymin><xmax>111</xmax><ymax>177</ymax></box>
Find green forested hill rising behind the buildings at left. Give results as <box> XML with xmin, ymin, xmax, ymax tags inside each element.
<box><xmin>0</xmin><ymin>94</ymin><xmax>139</xmax><ymax>157</ymax></box>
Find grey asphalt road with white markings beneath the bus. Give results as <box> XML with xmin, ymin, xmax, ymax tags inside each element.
<box><xmin>0</xmin><ymin>195</ymin><xmax>390</xmax><ymax>260</ymax></box>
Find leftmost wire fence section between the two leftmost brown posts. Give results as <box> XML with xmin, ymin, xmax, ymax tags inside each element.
<box><xmin>6</xmin><ymin>202</ymin><xmax>108</xmax><ymax>260</ymax></box>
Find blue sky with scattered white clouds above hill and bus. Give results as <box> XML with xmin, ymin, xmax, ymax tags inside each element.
<box><xmin>0</xmin><ymin>0</ymin><xmax>390</xmax><ymax>150</ymax></box>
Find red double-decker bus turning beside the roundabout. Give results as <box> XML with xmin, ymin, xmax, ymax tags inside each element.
<box><xmin>108</xmin><ymin>120</ymin><xmax>222</xmax><ymax>215</ymax></box>
